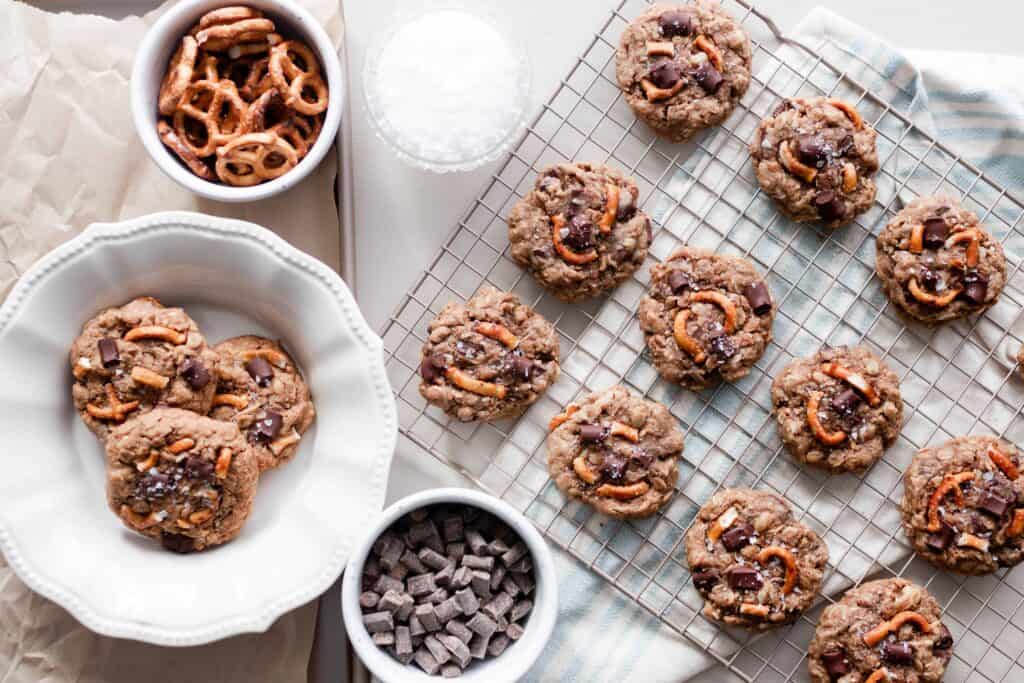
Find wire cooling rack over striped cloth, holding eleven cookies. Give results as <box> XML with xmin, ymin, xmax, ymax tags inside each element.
<box><xmin>383</xmin><ymin>0</ymin><xmax>1024</xmax><ymax>681</ymax></box>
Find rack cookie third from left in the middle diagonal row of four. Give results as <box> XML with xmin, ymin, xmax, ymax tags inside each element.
<box><xmin>771</xmin><ymin>346</ymin><xmax>903</xmax><ymax>472</ymax></box>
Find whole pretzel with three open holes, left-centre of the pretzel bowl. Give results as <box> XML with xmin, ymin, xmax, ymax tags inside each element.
<box><xmin>173</xmin><ymin>80</ymin><xmax>246</xmax><ymax>157</ymax></box>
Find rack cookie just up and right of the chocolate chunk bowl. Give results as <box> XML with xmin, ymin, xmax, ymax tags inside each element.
<box><xmin>547</xmin><ymin>386</ymin><xmax>683</xmax><ymax>519</ymax></box>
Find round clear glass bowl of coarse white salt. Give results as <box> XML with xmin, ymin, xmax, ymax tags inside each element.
<box><xmin>362</xmin><ymin>6</ymin><xmax>530</xmax><ymax>173</ymax></box>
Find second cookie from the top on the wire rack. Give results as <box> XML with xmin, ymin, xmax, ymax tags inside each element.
<box><xmin>751</xmin><ymin>97</ymin><xmax>879</xmax><ymax>228</ymax></box>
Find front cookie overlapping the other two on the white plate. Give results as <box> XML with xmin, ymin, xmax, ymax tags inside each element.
<box><xmin>106</xmin><ymin>408</ymin><xmax>259</xmax><ymax>553</ymax></box>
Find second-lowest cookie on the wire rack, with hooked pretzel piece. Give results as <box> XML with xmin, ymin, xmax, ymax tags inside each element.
<box><xmin>686</xmin><ymin>488</ymin><xmax>828</xmax><ymax>631</ymax></box>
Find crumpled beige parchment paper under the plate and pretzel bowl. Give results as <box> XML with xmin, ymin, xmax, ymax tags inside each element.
<box><xmin>0</xmin><ymin>0</ymin><xmax>344</xmax><ymax>683</ymax></box>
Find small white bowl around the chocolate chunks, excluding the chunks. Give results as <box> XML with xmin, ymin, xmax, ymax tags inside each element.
<box><xmin>341</xmin><ymin>488</ymin><xmax>558</xmax><ymax>683</ymax></box>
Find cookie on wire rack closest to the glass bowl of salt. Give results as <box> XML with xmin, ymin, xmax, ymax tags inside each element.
<box><xmin>509</xmin><ymin>164</ymin><xmax>651</xmax><ymax>303</ymax></box>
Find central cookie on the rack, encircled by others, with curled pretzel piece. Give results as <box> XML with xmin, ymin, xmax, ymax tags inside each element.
<box><xmin>639</xmin><ymin>247</ymin><xmax>775</xmax><ymax>390</ymax></box>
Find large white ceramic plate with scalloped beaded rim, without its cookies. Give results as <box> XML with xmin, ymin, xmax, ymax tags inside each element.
<box><xmin>0</xmin><ymin>213</ymin><xmax>396</xmax><ymax>645</ymax></box>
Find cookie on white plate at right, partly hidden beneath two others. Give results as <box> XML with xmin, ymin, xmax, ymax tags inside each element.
<box><xmin>210</xmin><ymin>335</ymin><xmax>316</xmax><ymax>472</ymax></box>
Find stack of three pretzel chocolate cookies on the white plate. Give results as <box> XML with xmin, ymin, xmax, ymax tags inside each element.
<box><xmin>70</xmin><ymin>297</ymin><xmax>315</xmax><ymax>553</ymax></box>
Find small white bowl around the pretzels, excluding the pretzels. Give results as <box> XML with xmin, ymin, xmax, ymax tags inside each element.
<box><xmin>131</xmin><ymin>0</ymin><xmax>345</xmax><ymax>202</ymax></box>
